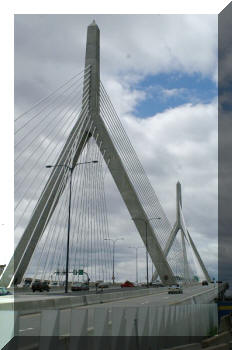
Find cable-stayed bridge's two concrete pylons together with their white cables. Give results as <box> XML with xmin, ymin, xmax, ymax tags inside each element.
<box><xmin>0</xmin><ymin>22</ymin><xmax>210</xmax><ymax>292</ymax></box>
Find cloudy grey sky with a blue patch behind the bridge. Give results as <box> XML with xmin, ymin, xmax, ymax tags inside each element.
<box><xmin>8</xmin><ymin>15</ymin><xmax>217</xmax><ymax>279</ymax></box>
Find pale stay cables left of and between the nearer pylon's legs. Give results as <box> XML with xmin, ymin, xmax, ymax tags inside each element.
<box><xmin>15</xmin><ymin>67</ymin><xmax>112</xmax><ymax>281</ymax></box>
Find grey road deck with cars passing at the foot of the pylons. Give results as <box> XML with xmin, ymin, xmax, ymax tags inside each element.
<box><xmin>0</xmin><ymin>284</ymin><xmax>221</xmax><ymax>312</ymax></box>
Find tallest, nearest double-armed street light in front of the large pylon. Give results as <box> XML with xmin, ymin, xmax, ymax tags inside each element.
<box><xmin>46</xmin><ymin>160</ymin><xmax>98</xmax><ymax>293</ymax></box>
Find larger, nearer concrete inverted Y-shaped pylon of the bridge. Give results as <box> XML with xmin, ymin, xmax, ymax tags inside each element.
<box><xmin>0</xmin><ymin>22</ymin><xmax>175</xmax><ymax>286</ymax></box>
